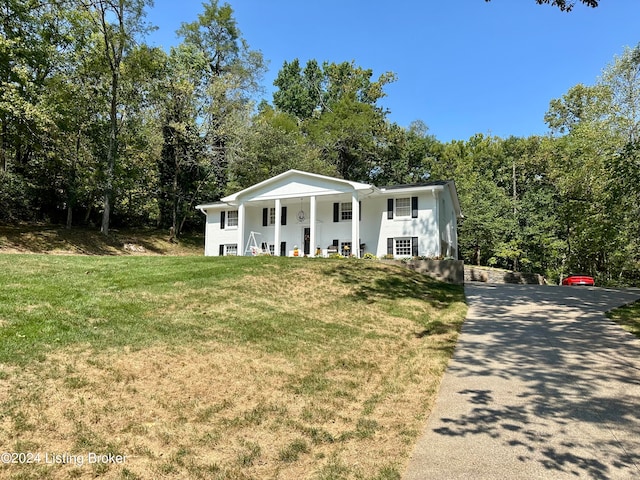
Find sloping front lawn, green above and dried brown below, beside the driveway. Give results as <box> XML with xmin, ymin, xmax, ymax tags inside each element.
<box><xmin>0</xmin><ymin>255</ymin><xmax>466</xmax><ymax>480</ymax></box>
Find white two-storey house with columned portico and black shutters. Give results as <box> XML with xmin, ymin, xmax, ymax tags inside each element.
<box><xmin>196</xmin><ymin>170</ymin><xmax>462</xmax><ymax>258</ymax></box>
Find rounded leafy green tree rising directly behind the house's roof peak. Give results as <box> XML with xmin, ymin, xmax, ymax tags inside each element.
<box><xmin>273</xmin><ymin>59</ymin><xmax>395</xmax><ymax>181</ymax></box>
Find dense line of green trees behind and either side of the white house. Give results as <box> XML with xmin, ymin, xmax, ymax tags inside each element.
<box><xmin>0</xmin><ymin>0</ymin><xmax>640</xmax><ymax>284</ymax></box>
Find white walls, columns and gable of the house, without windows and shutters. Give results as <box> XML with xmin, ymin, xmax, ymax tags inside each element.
<box><xmin>200</xmin><ymin>174</ymin><xmax>457</xmax><ymax>257</ymax></box>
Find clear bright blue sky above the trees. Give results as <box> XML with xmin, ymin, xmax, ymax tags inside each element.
<box><xmin>147</xmin><ymin>0</ymin><xmax>640</xmax><ymax>142</ymax></box>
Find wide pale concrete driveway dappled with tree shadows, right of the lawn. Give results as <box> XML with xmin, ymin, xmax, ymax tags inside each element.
<box><xmin>404</xmin><ymin>284</ymin><xmax>640</xmax><ymax>480</ymax></box>
